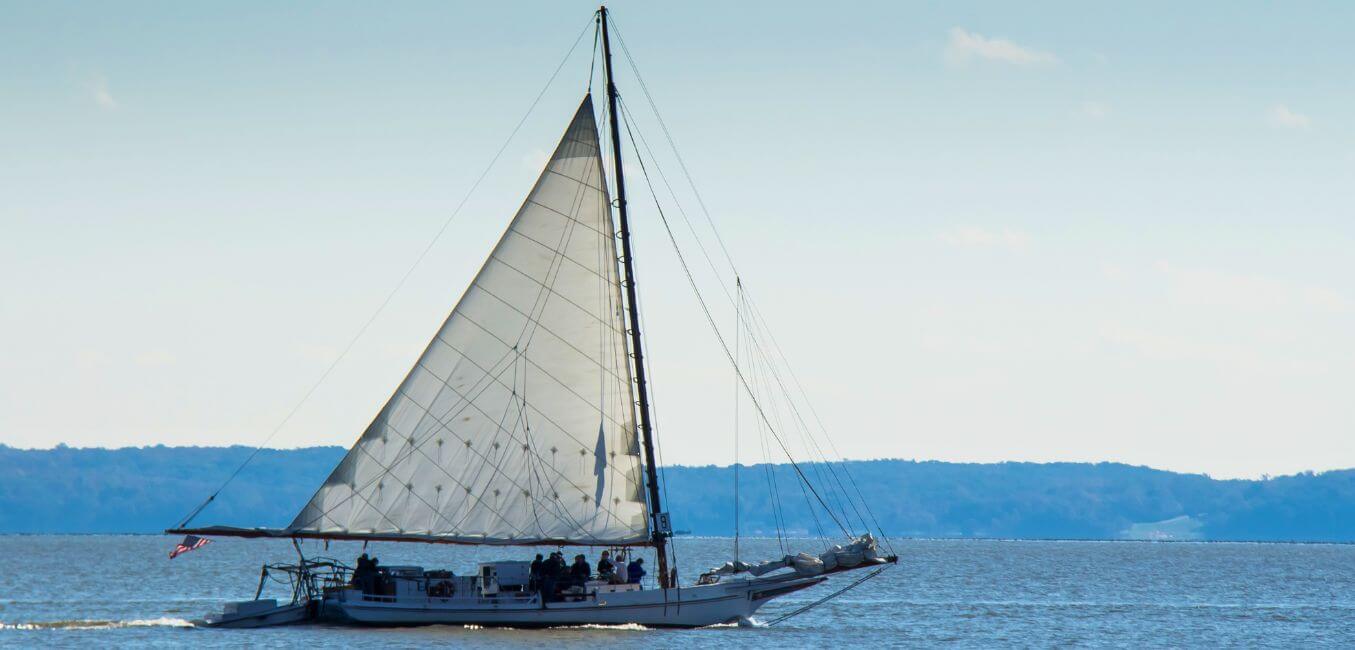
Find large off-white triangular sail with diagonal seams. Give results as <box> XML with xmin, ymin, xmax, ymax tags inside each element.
<box><xmin>287</xmin><ymin>96</ymin><xmax>650</xmax><ymax>544</ymax></box>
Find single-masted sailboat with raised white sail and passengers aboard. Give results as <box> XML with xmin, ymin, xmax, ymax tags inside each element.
<box><xmin>167</xmin><ymin>7</ymin><xmax>897</xmax><ymax>627</ymax></box>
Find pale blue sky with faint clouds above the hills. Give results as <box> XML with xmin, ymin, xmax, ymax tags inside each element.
<box><xmin>0</xmin><ymin>3</ymin><xmax>1355</xmax><ymax>477</ymax></box>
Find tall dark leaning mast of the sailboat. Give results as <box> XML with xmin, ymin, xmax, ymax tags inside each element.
<box><xmin>598</xmin><ymin>5</ymin><xmax>669</xmax><ymax>589</ymax></box>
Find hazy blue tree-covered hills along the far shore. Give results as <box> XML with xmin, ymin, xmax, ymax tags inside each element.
<box><xmin>0</xmin><ymin>446</ymin><xmax>1355</xmax><ymax>542</ymax></box>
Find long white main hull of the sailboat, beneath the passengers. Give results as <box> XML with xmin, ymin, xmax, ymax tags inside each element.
<box><xmin>320</xmin><ymin>576</ymin><xmax>827</xmax><ymax>627</ymax></box>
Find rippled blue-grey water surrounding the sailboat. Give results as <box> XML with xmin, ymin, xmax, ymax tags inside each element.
<box><xmin>0</xmin><ymin>535</ymin><xmax>1355</xmax><ymax>647</ymax></box>
